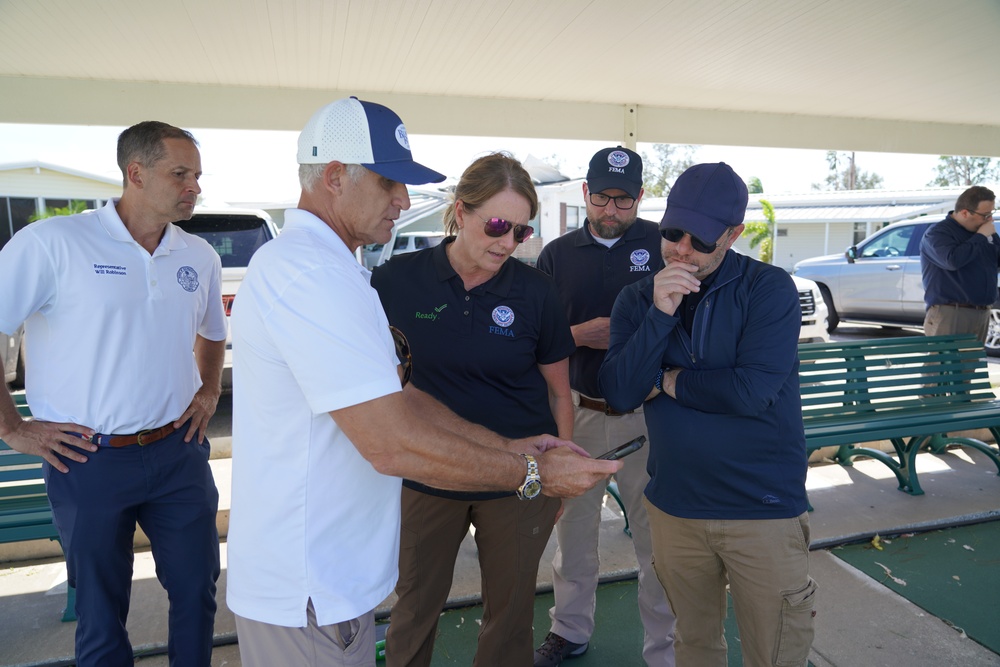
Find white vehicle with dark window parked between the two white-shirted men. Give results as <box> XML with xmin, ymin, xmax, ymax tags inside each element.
<box><xmin>174</xmin><ymin>209</ymin><xmax>278</xmax><ymax>389</ymax></box>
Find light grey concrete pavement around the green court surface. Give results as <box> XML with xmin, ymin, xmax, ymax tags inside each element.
<box><xmin>0</xmin><ymin>440</ymin><xmax>1000</xmax><ymax>667</ymax></box>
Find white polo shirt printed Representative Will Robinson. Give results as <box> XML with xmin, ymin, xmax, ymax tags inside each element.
<box><xmin>0</xmin><ymin>200</ymin><xmax>226</xmax><ymax>433</ymax></box>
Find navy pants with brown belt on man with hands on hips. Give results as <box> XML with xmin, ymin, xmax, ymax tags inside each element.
<box><xmin>45</xmin><ymin>424</ymin><xmax>219</xmax><ymax>667</ymax></box>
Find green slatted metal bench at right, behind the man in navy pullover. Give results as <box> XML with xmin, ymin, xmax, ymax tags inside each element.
<box><xmin>799</xmin><ymin>335</ymin><xmax>1000</xmax><ymax>495</ymax></box>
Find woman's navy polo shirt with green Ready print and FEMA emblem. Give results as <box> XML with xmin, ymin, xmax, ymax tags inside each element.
<box><xmin>372</xmin><ymin>238</ymin><xmax>575</xmax><ymax>499</ymax></box>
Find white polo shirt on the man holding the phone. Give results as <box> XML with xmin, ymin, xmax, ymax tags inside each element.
<box><xmin>226</xmin><ymin>209</ymin><xmax>400</xmax><ymax>627</ymax></box>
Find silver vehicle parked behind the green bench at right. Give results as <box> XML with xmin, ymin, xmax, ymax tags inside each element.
<box><xmin>794</xmin><ymin>219</ymin><xmax>1000</xmax><ymax>356</ymax></box>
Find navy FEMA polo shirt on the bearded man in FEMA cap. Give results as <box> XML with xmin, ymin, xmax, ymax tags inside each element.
<box><xmin>536</xmin><ymin>218</ymin><xmax>663</xmax><ymax>398</ymax></box>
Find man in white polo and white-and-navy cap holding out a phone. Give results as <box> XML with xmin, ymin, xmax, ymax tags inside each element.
<box><xmin>226</xmin><ymin>98</ymin><xmax>621</xmax><ymax>667</ymax></box>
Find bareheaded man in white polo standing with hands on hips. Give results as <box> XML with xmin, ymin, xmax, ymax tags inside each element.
<box><xmin>0</xmin><ymin>121</ymin><xmax>226</xmax><ymax>667</ymax></box>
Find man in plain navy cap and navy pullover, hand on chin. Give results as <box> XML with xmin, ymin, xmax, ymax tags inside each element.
<box><xmin>600</xmin><ymin>162</ymin><xmax>816</xmax><ymax>667</ymax></box>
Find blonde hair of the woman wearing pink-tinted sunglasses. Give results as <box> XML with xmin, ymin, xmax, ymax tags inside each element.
<box><xmin>444</xmin><ymin>152</ymin><xmax>538</xmax><ymax>236</ymax></box>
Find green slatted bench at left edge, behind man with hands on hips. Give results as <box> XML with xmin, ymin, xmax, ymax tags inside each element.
<box><xmin>0</xmin><ymin>395</ymin><xmax>76</xmax><ymax>621</ymax></box>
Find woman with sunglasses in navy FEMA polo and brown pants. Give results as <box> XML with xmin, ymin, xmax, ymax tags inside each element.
<box><xmin>372</xmin><ymin>153</ymin><xmax>574</xmax><ymax>667</ymax></box>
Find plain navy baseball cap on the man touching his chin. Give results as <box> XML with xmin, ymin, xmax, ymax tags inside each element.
<box><xmin>660</xmin><ymin>162</ymin><xmax>749</xmax><ymax>243</ymax></box>
